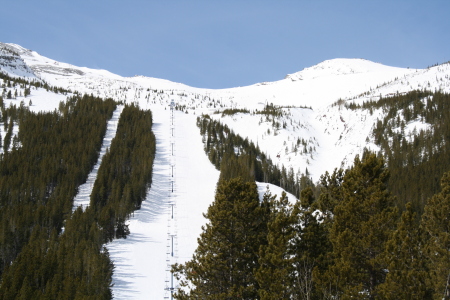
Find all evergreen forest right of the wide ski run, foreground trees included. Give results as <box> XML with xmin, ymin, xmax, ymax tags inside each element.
<box><xmin>173</xmin><ymin>91</ymin><xmax>450</xmax><ymax>299</ymax></box>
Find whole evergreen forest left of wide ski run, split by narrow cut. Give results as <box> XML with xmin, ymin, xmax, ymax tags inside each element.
<box><xmin>0</xmin><ymin>73</ymin><xmax>155</xmax><ymax>299</ymax></box>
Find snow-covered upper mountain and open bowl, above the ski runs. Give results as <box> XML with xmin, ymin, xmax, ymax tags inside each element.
<box><xmin>0</xmin><ymin>43</ymin><xmax>450</xmax><ymax>180</ymax></box>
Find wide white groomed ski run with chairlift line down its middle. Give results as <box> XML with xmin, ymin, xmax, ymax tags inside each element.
<box><xmin>106</xmin><ymin>106</ymin><xmax>219</xmax><ymax>300</ymax></box>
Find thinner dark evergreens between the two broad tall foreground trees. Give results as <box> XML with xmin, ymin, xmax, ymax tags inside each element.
<box><xmin>256</xmin><ymin>187</ymin><xmax>331</xmax><ymax>299</ymax></box>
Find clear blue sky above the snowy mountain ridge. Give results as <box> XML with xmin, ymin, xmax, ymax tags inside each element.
<box><xmin>0</xmin><ymin>0</ymin><xmax>450</xmax><ymax>88</ymax></box>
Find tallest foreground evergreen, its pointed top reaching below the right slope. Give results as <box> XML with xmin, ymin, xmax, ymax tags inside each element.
<box><xmin>326</xmin><ymin>151</ymin><xmax>397</xmax><ymax>299</ymax></box>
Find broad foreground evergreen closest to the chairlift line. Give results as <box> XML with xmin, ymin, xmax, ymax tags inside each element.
<box><xmin>172</xmin><ymin>178</ymin><xmax>270</xmax><ymax>300</ymax></box>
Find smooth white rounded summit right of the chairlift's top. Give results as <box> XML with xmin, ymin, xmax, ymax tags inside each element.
<box><xmin>209</xmin><ymin>59</ymin><xmax>415</xmax><ymax>108</ymax></box>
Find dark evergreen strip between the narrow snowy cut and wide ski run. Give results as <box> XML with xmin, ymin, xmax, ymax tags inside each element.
<box><xmin>91</xmin><ymin>105</ymin><xmax>156</xmax><ymax>242</ymax></box>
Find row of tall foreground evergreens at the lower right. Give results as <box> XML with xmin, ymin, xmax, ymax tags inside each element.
<box><xmin>172</xmin><ymin>151</ymin><xmax>450</xmax><ymax>299</ymax></box>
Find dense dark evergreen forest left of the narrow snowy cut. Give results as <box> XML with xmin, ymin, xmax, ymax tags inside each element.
<box><xmin>0</xmin><ymin>96</ymin><xmax>116</xmax><ymax>299</ymax></box>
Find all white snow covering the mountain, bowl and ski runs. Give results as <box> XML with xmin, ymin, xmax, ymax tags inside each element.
<box><xmin>0</xmin><ymin>43</ymin><xmax>450</xmax><ymax>299</ymax></box>
